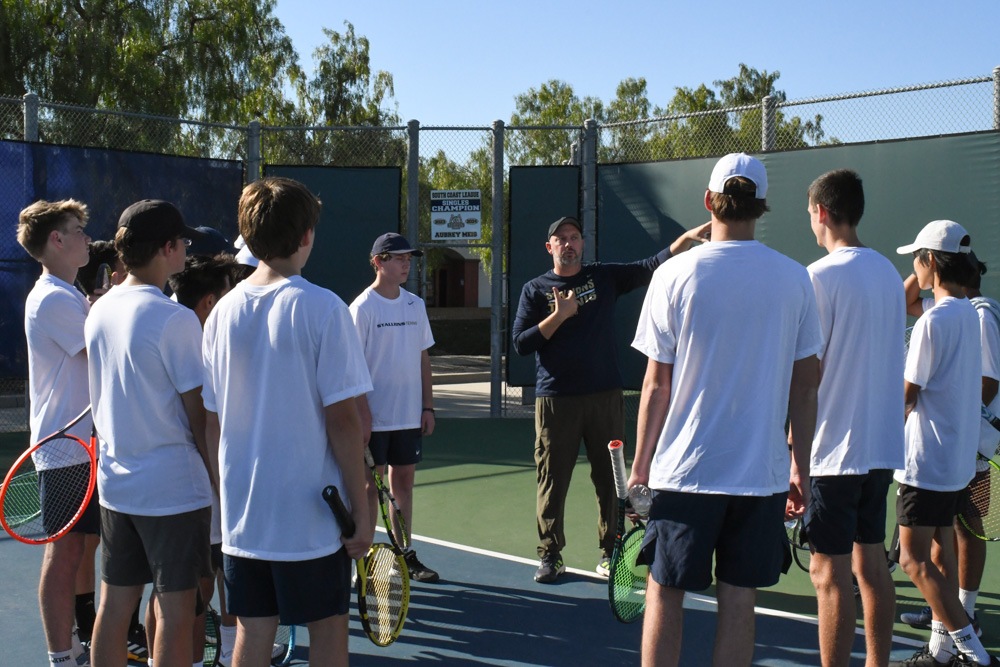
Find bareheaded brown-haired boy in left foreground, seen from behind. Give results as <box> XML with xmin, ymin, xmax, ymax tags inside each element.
<box><xmin>202</xmin><ymin>178</ymin><xmax>374</xmax><ymax>665</ymax></box>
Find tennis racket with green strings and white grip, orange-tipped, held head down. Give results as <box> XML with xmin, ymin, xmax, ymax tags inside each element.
<box><xmin>608</xmin><ymin>440</ymin><xmax>649</xmax><ymax>623</ymax></box>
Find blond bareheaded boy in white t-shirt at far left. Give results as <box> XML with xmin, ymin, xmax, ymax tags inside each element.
<box><xmin>17</xmin><ymin>199</ymin><xmax>100</xmax><ymax>665</ymax></box>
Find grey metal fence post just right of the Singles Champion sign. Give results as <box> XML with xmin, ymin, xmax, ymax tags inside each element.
<box><xmin>490</xmin><ymin>120</ymin><xmax>507</xmax><ymax>417</ymax></box>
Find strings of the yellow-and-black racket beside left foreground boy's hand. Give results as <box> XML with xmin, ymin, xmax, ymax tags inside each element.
<box><xmin>365</xmin><ymin>548</ymin><xmax>409</xmax><ymax>646</ymax></box>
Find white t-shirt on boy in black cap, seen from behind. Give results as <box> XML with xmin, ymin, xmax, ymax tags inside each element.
<box><xmin>86</xmin><ymin>285</ymin><xmax>212</xmax><ymax>516</ymax></box>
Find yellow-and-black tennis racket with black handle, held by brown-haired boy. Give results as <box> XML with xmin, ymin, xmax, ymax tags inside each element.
<box><xmin>323</xmin><ymin>486</ymin><xmax>410</xmax><ymax>646</ymax></box>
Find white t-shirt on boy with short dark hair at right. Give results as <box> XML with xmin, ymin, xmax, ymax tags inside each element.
<box><xmin>808</xmin><ymin>248</ymin><xmax>906</xmax><ymax>477</ymax></box>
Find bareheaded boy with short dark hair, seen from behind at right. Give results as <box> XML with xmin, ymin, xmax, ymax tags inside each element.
<box><xmin>805</xmin><ymin>169</ymin><xmax>906</xmax><ymax>667</ymax></box>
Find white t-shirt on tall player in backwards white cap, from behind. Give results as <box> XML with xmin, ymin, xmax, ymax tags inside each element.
<box><xmin>632</xmin><ymin>241</ymin><xmax>823</xmax><ymax>496</ymax></box>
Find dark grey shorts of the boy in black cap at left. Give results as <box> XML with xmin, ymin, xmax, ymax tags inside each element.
<box><xmin>101</xmin><ymin>507</ymin><xmax>212</xmax><ymax>593</ymax></box>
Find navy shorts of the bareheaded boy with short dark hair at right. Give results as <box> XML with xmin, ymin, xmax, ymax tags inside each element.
<box><xmin>804</xmin><ymin>469</ymin><xmax>893</xmax><ymax>556</ymax></box>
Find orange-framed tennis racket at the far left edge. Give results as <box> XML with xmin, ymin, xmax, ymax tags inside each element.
<box><xmin>0</xmin><ymin>406</ymin><xmax>97</xmax><ymax>544</ymax></box>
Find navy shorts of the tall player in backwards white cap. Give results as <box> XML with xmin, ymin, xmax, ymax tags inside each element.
<box><xmin>638</xmin><ymin>491</ymin><xmax>788</xmax><ymax>591</ymax></box>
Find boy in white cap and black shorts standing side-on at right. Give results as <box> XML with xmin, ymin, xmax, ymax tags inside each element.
<box><xmin>895</xmin><ymin>220</ymin><xmax>1000</xmax><ymax>667</ymax></box>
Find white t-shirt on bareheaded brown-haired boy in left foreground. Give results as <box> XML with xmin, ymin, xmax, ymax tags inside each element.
<box><xmin>202</xmin><ymin>276</ymin><xmax>372</xmax><ymax>561</ymax></box>
